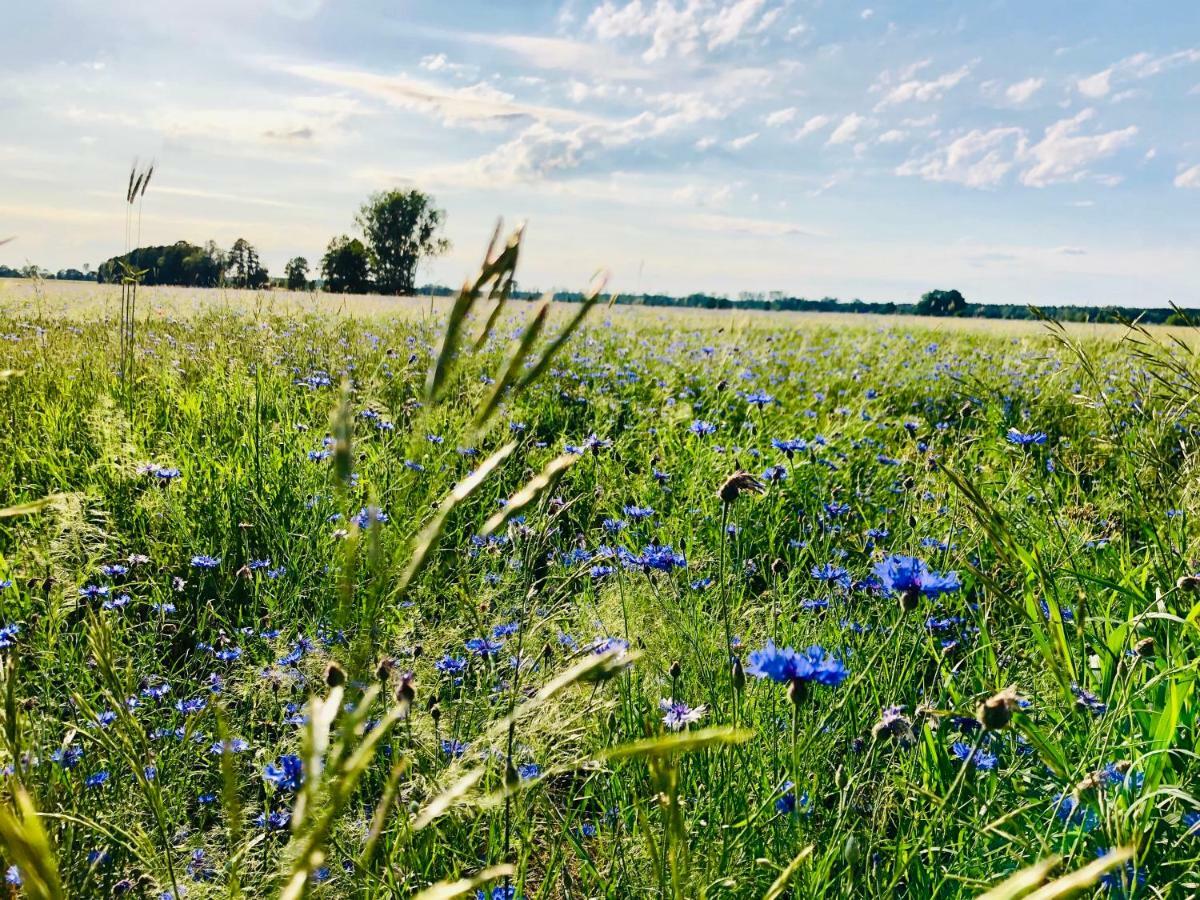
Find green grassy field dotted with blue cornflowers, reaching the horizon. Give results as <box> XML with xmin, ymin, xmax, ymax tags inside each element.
<box><xmin>0</xmin><ymin>255</ymin><xmax>1200</xmax><ymax>900</ymax></box>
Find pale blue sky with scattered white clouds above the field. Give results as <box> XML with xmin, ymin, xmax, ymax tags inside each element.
<box><xmin>0</xmin><ymin>0</ymin><xmax>1200</xmax><ymax>306</ymax></box>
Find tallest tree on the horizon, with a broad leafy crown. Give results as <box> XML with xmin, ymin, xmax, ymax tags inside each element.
<box><xmin>355</xmin><ymin>191</ymin><xmax>450</xmax><ymax>294</ymax></box>
